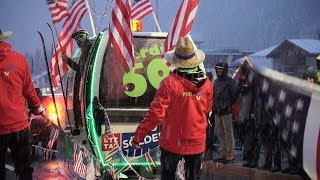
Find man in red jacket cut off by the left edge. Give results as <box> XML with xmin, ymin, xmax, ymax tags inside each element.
<box><xmin>0</xmin><ymin>30</ymin><xmax>45</xmax><ymax>179</ymax></box>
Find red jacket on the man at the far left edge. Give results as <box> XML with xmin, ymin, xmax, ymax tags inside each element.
<box><xmin>0</xmin><ymin>42</ymin><xmax>41</xmax><ymax>135</ymax></box>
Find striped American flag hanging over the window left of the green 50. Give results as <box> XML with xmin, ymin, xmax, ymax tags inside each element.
<box><xmin>108</xmin><ymin>0</ymin><xmax>134</xmax><ymax>72</ymax></box>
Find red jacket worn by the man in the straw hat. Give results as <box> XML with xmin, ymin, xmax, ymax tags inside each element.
<box><xmin>134</xmin><ymin>73</ymin><xmax>213</xmax><ymax>155</ymax></box>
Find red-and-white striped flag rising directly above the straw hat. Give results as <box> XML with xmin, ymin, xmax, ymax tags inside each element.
<box><xmin>164</xmin><ymin>0</ymin><xmax>199</xmax><ymax>69</ymax></box>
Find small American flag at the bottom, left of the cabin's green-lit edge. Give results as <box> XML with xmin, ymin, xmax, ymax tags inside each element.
<box><xmin>73</xmin><ymin>143</ymin><xmax>90</xmax><ymax>178</ymax></box>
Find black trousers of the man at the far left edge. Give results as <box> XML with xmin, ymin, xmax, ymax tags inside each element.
<box><xmin>0</xmin><ymin>128</ymin><xmax>33</xmax><ymax>180</ymax></box>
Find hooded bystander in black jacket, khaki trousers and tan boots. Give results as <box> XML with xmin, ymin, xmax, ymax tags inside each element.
<box><xmin>212</xmin><ymin>62</ymin><xmax>237</xmax><ymax>163</ymax></box>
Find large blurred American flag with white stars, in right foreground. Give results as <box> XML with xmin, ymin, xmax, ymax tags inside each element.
<box><xmin>241</xmin><ymin>59</ymin><xmax>320</xmax><ymax>179</ymax></box>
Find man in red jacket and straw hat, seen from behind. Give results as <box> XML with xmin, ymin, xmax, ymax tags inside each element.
<box><xmin>132</xmin><ymin>37</ymin><xmax>213</xmax><ymax>180</ymax></box>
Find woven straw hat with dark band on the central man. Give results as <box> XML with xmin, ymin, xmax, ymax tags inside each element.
<box><xmin>164</xmin><ymin>36</ymin><xmax>205</xmax><ymax>68</ymax></box>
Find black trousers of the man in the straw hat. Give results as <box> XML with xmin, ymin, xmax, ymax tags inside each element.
<box><xmin>160</xmin><ymin>148</ymin><xmax>203</xmax><ymax>180</ymax></box>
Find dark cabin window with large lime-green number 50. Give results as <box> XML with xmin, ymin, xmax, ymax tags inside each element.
<box><xmin>99</xmin><ymin>36</ymin><xmax>169</xmax><ymax>108</ymax></box>
